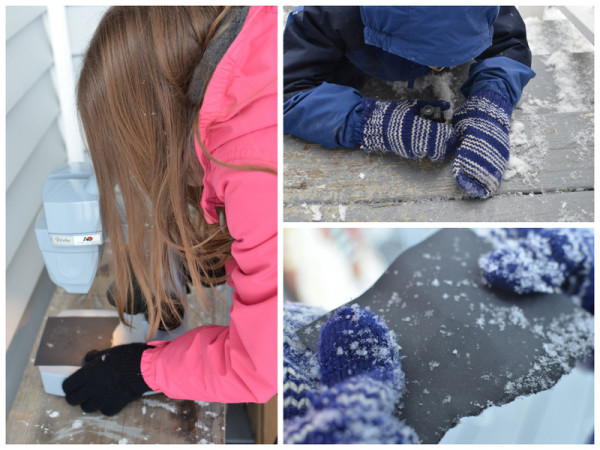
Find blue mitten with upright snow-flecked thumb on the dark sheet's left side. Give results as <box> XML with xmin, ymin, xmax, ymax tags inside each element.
<box><xmin>285</xmin><ymin>307</ymin><xmax>419</xmax><ymax>444</ymax></box>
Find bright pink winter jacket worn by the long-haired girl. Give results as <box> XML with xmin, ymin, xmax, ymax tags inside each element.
<box><xmin>141</xmin><ymin>6</ymin><xmax>277</xmax><ymax>403</ymax></box>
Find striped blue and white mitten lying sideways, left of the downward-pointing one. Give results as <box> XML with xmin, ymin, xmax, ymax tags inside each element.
<box><xmin>360</xmin><ymin>98</ymin><xmax>457</xmax><ymax>161</ymax></box>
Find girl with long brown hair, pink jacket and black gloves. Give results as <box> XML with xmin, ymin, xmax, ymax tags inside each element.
<box><xmin>63</xmin><ymin>6</ymin><xmax>277</xmax><ymax>415</ymax></box>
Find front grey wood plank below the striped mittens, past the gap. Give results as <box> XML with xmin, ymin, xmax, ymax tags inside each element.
<box><xmin>284</xmin><ymin>191</ymin><xmax>594</xmax><ymax>222</ymax></box>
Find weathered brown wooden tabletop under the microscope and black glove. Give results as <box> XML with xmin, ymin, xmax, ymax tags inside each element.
<box><xmin>6</xmin><ymin>249</ymin><xmax>227</xmax><ymax>444</ymax></box>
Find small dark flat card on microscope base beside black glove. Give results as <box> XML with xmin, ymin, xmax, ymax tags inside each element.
<box><xmin>35</xmin><ymin>316</ymin><xmax>119</xmax><ymax>366</ymax></box>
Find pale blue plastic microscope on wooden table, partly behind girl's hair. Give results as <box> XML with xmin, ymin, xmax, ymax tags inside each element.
<box><xmin>35</xmin><ymin>162</ymin><xmax>191</xmax><ymax>395</ymax></box>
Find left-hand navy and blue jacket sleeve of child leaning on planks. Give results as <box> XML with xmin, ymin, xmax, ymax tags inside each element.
<box><xmin>283</xmin><ymin>7</ymin><xmax>363</xmax><ymax>147</ymax></box>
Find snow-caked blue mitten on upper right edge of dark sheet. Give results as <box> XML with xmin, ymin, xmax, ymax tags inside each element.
<box><xmin>479</xmin><ymin>228</ymin><xmax>594</xmax><ymax>313</ymax></box>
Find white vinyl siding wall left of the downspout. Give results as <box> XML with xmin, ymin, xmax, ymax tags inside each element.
<box><xmin>5</xmin><ymin>6</ymin><xmax>66</xmax><ymax>345</ymax></box>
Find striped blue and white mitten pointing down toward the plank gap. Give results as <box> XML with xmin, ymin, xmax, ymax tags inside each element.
<box><xmin>452</xmin><ymin>91</ymin><xmax>513</xmax><ymax>198</ymax></box>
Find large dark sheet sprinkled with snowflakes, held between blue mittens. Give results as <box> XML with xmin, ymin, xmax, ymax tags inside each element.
<box><xmin>299</xmin><ymin>229</ymin><xmax>593</xmax><ymax>443</ymax></box>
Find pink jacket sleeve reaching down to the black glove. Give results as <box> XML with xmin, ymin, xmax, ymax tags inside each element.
<box><xmin>141</xmin><ymin>165</ymin><xmax>277</xmax><ymax>403</ymax></box>
